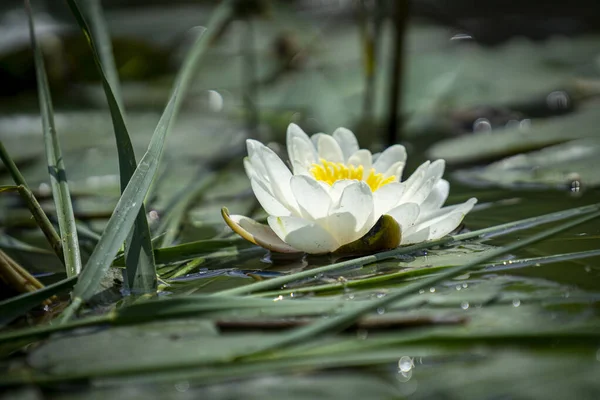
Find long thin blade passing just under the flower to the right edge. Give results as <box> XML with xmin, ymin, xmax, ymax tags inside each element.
<box><xmin>214</xmin><ymin>204</ymin><xmax>600</xmax><ymax>296</ymax></box>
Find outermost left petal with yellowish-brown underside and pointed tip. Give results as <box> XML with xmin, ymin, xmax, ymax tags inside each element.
<box><xmin>221</xmin><ymin>209</ymin><xmax>298</xmax><ymax>253</ymax></box>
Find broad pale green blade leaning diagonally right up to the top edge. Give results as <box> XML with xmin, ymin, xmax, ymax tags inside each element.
<box><xmin>61</xmin><ymin>0</ymin><xmax>231</xmax><ymax>322</ymax></box>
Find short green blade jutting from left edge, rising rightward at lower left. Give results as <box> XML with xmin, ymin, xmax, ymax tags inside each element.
<box><xmin>0</xmin><ymin>276</ymin><xmax>77</xmax><ymax>326</ymax></box>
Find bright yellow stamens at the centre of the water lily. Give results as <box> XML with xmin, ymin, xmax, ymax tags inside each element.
<box><xmin>310</xmin><ymin>159</ymin><xmax>396</xmax><ymax>192</ymax></box>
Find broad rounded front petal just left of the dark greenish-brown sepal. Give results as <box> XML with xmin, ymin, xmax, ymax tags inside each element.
<box><xmin>327</xmin><ymin>181</ymin><xmax>374</xmax><ymax>245</ymax></box>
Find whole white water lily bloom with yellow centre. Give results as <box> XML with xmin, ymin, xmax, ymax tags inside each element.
<box><xmin>223</xmin><ymin>124</ymin><xmax>477</xmax><ymax>254</ymax></box>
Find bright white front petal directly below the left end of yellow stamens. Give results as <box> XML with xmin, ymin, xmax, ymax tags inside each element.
<box><xmin>290</xmin><ymin>175</ymin><xmax>331</xmax><ymax>222</ymax></box>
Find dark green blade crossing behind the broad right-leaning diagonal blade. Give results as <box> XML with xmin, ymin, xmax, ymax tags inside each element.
<box><xmin>67</xmin><ymin>0</ymin><xmax>158</xmax><ymax>294</ymax></box>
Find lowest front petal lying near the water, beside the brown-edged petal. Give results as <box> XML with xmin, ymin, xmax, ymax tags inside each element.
<box><xmin>268</xmin><ymin>217</ymin><xmax>340</xmax><ymax>254</ymax></box>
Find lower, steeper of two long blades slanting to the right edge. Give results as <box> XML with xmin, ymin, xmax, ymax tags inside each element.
<box><xmin>240</xmin><ymin>212</ymin><xmax>600</xmax><ymax>358</ymax></box>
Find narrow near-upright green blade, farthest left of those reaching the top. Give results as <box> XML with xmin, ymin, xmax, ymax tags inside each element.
<box><xmin>25</xmin><ymin>0</ymin><xmax>81</xmax><ymax>276</ymax></box>
